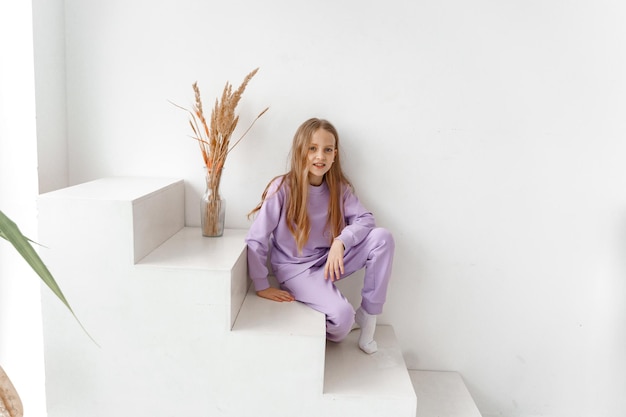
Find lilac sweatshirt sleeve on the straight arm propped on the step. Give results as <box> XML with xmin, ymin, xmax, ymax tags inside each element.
<box><xmin>246</xmin><ymin>179</ymin><xmax>284</xmax><ymax>291</ymax></box>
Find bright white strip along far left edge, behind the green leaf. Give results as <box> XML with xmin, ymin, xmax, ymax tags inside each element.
<box><xmin>0</xmin><ymin>0</ymin><xmax>46</xmax><ymax>416</ymax></box>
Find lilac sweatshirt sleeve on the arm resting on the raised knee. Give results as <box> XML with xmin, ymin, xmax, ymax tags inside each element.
<box><xmin>337</xmin><ymin>187</ymin><xmax>376</xmax><ymax>250</ymax></box>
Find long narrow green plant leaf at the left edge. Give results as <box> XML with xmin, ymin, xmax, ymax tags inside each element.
<box><xmin>0</xmin><ymin>210</ymin><xmax>99</xmax><ymax>346</ymax></box>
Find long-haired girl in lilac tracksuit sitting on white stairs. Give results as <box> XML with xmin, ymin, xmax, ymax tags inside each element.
<box><xmin>246</xmin><ymin>118</ymin><xmax>394</xmax><ymax>353</ymax></box>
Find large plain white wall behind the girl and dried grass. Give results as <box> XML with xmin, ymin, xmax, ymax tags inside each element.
<box><xmin>35</xmin><ymin>0</ymin><xmax>626</xmax><ymax>417</ymax></box>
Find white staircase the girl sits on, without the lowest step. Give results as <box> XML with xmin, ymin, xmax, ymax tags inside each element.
<box><xmin>39</xmin><ymin>178</ymin><xmax>416</xmax><ymax>417</ymax></box>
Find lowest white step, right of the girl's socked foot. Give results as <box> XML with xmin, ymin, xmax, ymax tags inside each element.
<box><xmin>409</xmin><ymin>370</ymin><xmax>481</xmax><ymax>417</ymax></box>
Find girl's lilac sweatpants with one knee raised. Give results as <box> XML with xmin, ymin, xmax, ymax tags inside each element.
<box><xmin>281</xmin><ymin>228</ymin><xmax>395</xmax><ymax>342</ymax></box>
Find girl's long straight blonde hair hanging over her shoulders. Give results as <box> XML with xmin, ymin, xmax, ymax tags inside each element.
<box><xmin>248</xmin><ymin>118</ymin><xmax>352</xmax><ymax>252</ymax></box>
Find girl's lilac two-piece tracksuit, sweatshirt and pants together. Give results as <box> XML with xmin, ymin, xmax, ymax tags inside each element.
<box><xmin>246</xmin><ymin>177</ymin><xmax>394</xmax><ymax>341</ymax></box>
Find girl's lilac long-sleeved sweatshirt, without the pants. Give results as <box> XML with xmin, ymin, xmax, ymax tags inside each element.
<box><xmin>246</xmin><ymin>177</ymin><xmax>375</xmax><ymax>291</ymax></box>
